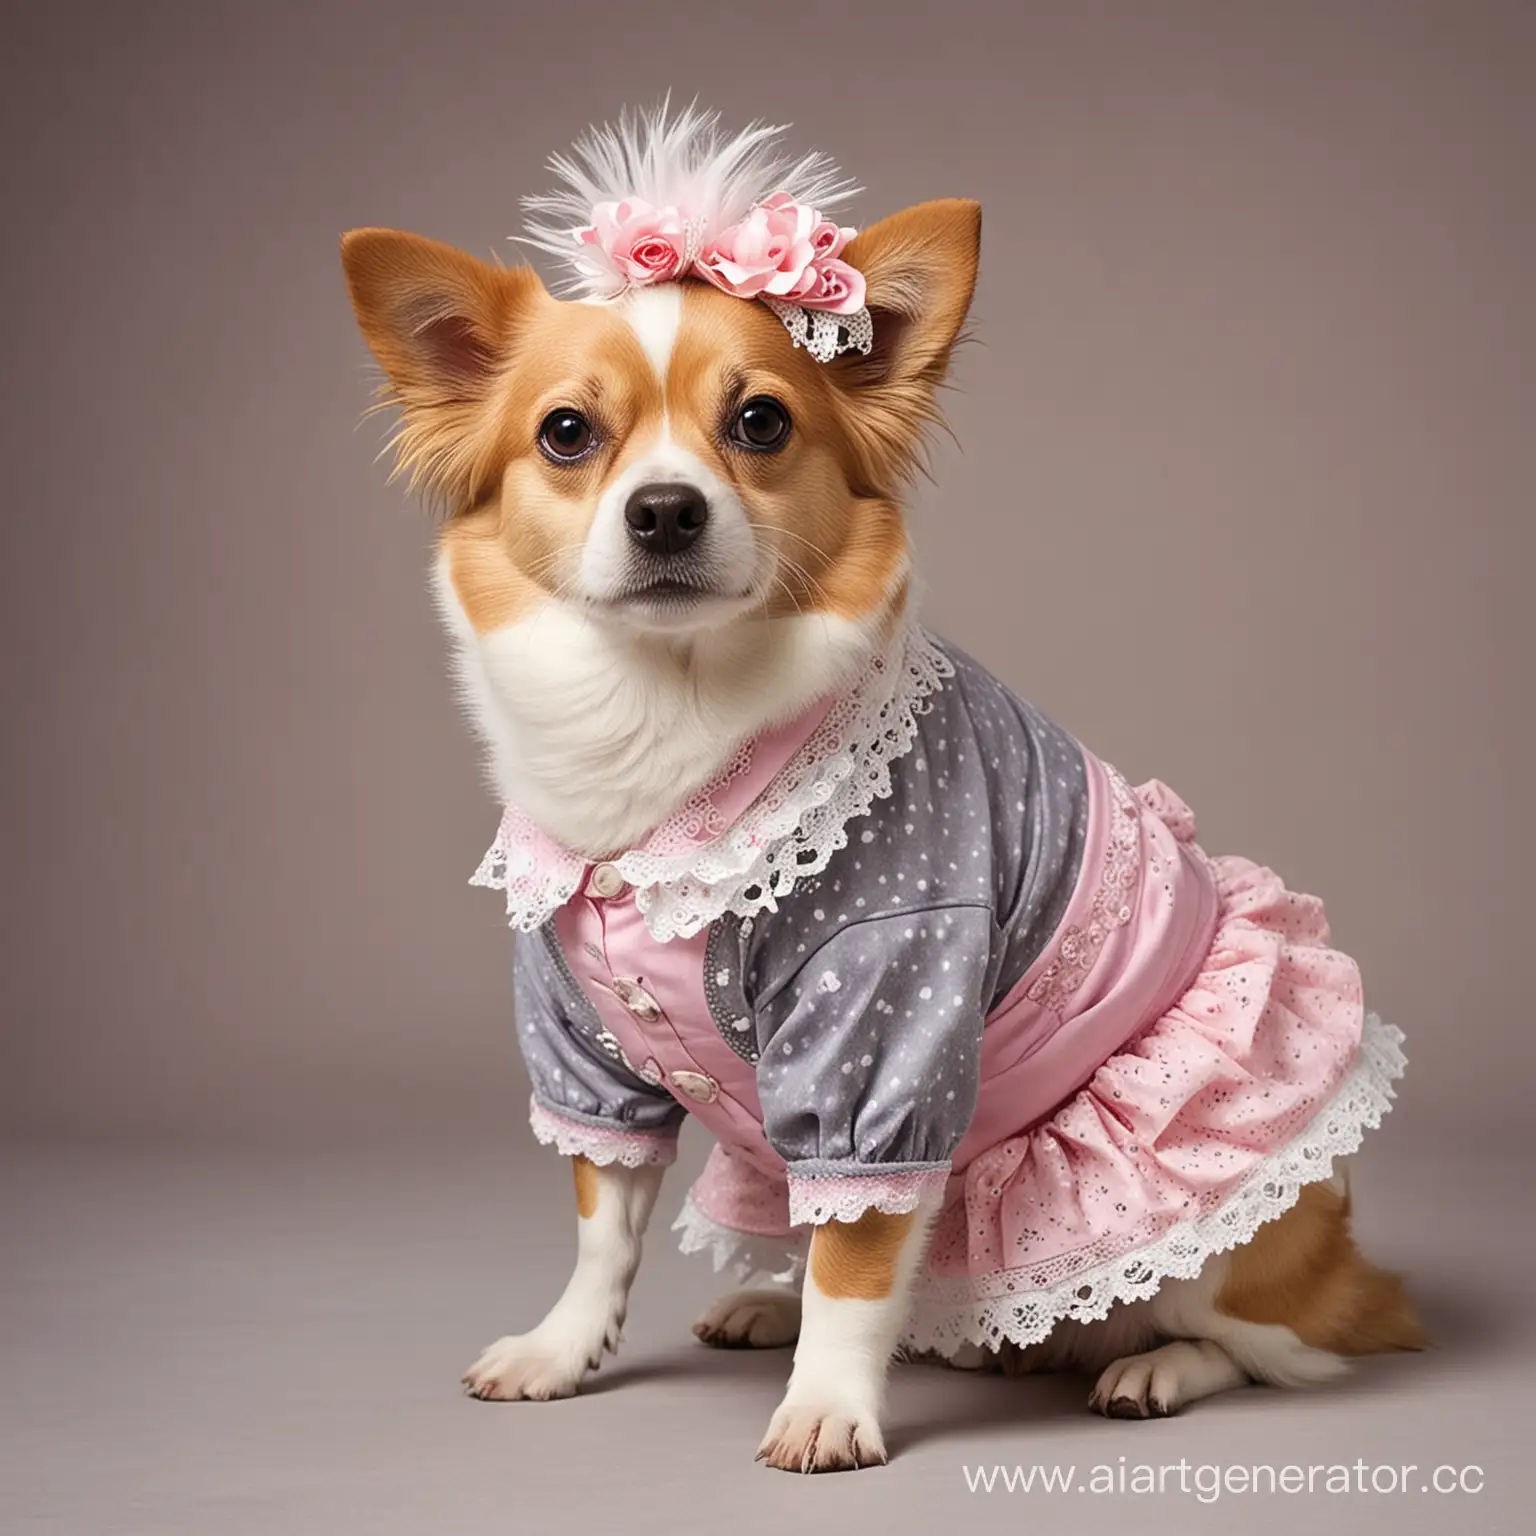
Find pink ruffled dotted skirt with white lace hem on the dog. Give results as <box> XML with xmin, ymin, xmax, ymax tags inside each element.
<box><xmin>672</xmin><ymin>770</ymin><xmax>1404</xmax><ymax>1355</ymax></box>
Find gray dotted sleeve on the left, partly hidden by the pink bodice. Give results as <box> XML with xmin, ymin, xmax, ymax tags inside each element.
<box><xmin>511</xmin><ymin>931</ymin><xmax>684</xmax><ymax>1150</ymax></box>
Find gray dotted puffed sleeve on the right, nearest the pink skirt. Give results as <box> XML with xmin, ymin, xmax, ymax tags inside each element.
<box><xmin>757</xmin><ymin>906</ymin><xmax>994</xmax><ymax>1220</ymax></box>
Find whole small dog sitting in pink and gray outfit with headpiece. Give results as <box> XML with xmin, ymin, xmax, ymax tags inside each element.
<box><xmin>343</xmin><ymin>108</ymin><xmax>1422</xmax><ymax>1470</ymax></box>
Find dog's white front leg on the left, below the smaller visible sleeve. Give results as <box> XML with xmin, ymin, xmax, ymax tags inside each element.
<box><xmin>464</xmin><ymin>1157</ymin><xmax>665</xmax><ymax>1401</ymax></box>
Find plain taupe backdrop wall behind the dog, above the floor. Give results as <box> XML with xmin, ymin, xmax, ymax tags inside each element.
<box><xmin>0</xmin><ymin>3</ymin><xmax>1536</xmax><ymax>1155</ymax></box>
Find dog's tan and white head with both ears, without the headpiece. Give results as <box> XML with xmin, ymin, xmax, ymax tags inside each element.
<box><xmin>343</xmin><ymin>118</ymin><xmax>980</xmax><ymax>634</ymax></box>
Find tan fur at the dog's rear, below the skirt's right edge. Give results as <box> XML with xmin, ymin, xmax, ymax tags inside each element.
<box><xmin>1217</xmin><ymin>1184</ymin><xmax>1427</xmax><ymax>1355</ymax></box>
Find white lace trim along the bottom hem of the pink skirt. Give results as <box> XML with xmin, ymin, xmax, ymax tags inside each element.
<box><xmin>902</xmin><ymin>1014</ymin><xmax>1405</xmax><ymax>1356</ymax></box>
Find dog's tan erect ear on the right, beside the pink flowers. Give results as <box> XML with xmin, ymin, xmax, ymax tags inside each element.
<box><xmin>829</xmin><ymin>198</ymin><xmax>982</xmax><ymax>488</ymax></box>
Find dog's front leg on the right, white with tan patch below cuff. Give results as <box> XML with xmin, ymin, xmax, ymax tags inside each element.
<box><xmin>757</xmin><ymin>1198</ymin><xmax>938</xmax><ymax>1471</ymax></box>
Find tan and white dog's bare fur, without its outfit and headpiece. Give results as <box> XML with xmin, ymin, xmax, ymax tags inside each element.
<box><xmin>343</xmin><ymin>111</ymin><xmax>1422</xmax><ymax>1470</ymax></box>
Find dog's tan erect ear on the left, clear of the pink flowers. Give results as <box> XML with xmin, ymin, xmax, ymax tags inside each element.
<box><xmin>341</xmin><ymin>229</ymin><xmax>547</xmax><ymax>507</ymax></box>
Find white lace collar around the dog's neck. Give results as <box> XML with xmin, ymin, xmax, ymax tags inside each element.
<box><xmin>470</xmin><ymin>624</ymin><xmax>954</xmax><ymax>942</ymax></box>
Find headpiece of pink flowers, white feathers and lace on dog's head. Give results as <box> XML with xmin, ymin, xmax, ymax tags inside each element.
<box><xmin>524</xmin><ymin>103</ymin><xmax>874</xmax><ymax>362</ymax></box>
